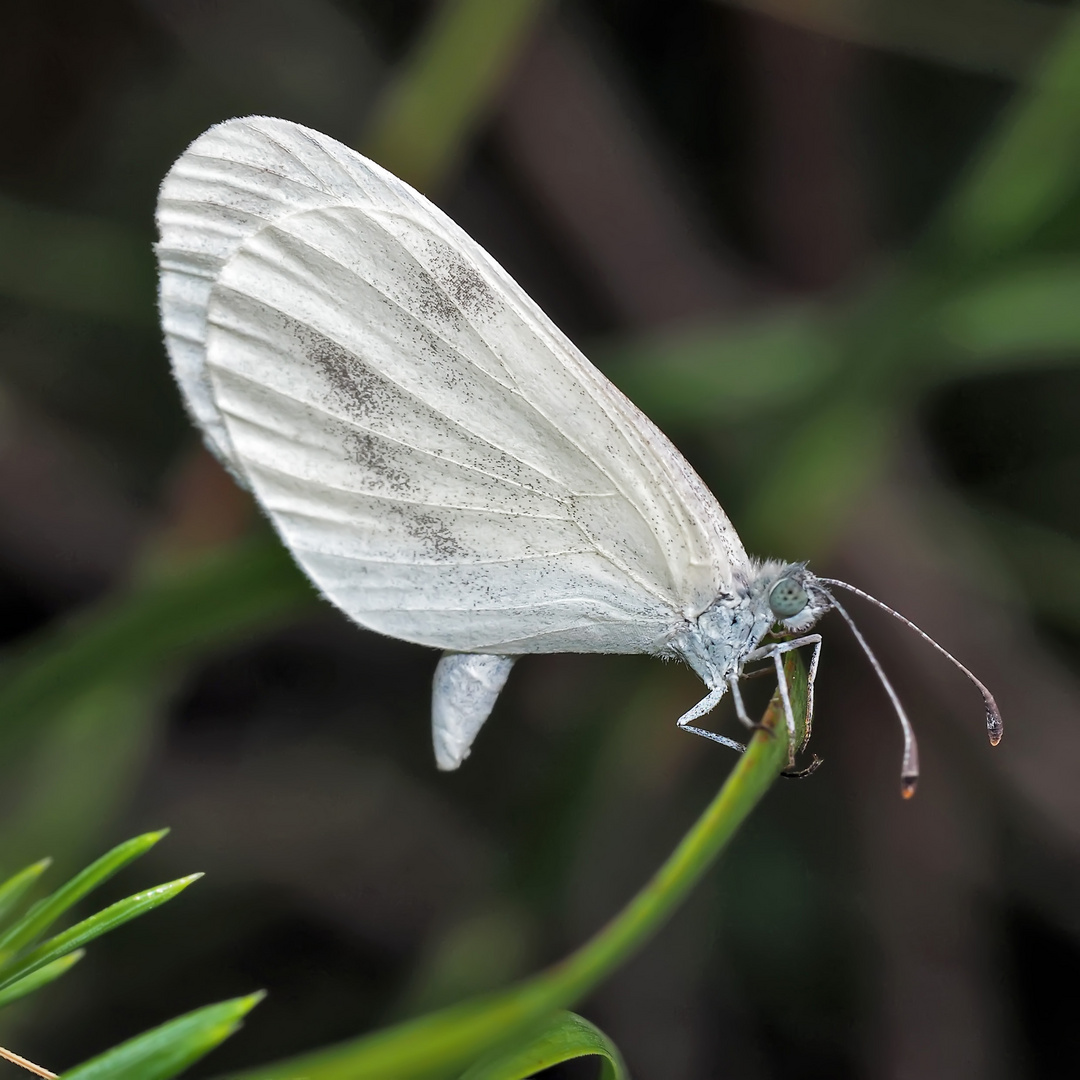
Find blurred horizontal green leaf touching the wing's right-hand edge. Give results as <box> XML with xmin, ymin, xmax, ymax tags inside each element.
<box><xmin>594</xmin><ymin>308</ymin><xmax>841</xmax><ymax>423</ymax></box>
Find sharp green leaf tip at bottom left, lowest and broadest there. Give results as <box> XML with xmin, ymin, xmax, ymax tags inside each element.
<box><xmin>62</xmin><ymin>994</ymin><xmax>265</xmax><ymax>1080</ymax></box>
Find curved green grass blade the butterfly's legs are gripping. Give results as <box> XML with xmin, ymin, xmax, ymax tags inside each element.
<box><xmin>225</xmin><ymin>654</ymin><xmax>806</xmax><ymax>1080</ymax></box>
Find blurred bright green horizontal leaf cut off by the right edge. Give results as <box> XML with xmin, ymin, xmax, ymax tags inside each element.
<box><xmin>940</xmin><ymin>258</ymin><xmax>1080</xmax><ymax>368</ymax></box>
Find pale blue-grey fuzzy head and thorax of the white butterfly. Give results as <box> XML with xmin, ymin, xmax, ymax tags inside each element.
<box><xmin>670</xmin><ymin>559</ymin><xmax>831</xmax><ymax>688</ymax></box>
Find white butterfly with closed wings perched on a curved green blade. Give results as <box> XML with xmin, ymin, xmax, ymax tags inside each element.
<box><xmin>157</xmin><ymin>117</ymin><xmax>1001</xmax><ymax>794</ymax></box>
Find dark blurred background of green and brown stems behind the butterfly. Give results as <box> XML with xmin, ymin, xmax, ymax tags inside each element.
<box><xmin>0</xmin><ymin>0</ymin><xmax>1080</xmax><ymax>1080</ymax></box>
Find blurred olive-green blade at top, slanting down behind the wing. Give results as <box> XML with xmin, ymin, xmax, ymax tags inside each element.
<box><xmin>363</xmin><ymin>0</ymin><xmax>543</xmax><ymax>191</ymax></box>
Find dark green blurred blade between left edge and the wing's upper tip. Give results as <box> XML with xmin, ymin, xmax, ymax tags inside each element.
<box><xmin>0</xmin><ymin>197</ymin><xmax>158</xmax><ymax>329</ymax></box>
